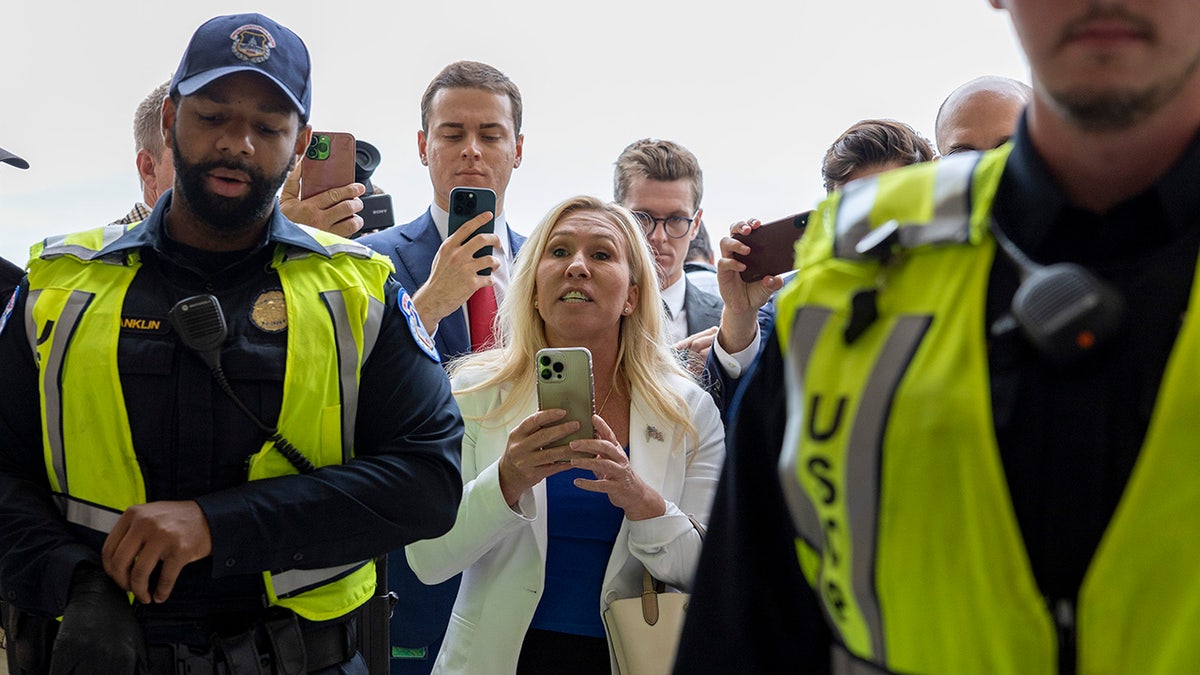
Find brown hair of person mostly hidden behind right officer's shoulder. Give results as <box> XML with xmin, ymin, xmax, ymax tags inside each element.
<box><xmin>821</xmin><ymin>119</ymin><xmax>934</xmax><ymax>192</ymax></box>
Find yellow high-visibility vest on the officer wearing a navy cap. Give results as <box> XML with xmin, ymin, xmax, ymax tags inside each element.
<box><xmin>25</xmin><ymin>225</ymin><xmax>391</xmax><ymax>621</ymax></box>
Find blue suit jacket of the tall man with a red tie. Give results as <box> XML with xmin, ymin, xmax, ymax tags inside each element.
<box><xmin>359</xmin><ymin>209</ymin><xmax>526</xmax><ymax>675</ymax></box>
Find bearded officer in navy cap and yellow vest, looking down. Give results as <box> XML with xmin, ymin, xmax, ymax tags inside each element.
<box><xmin>0</xmin><ymin>14</ymin><xmax>462</xmax><ymax>674</ymax></box>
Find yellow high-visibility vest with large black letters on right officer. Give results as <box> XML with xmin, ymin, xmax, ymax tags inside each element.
<box><xmin>776</xmin><ymin>147</ymin><xmax>1200</xmax><ymax>675</ymax></box>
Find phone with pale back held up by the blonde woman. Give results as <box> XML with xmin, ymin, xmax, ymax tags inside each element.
<box><xmin>534</xmin><ymin>347</ymin><xmax>595</xmax><ymax>446</ymax></box>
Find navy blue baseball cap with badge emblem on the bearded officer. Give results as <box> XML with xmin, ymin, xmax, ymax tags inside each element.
<box><xmin>170</xmin><ymin>14</ymin><xmax>312</xmax><ymax>123</ymax></box>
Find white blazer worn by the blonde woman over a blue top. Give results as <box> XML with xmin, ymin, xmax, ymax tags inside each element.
<box><xmin>400</xmin><ymin>367</ymin><xmax>725</xmax><ymax>675</ymax></box>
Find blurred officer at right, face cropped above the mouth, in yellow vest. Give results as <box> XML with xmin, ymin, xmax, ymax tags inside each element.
<box><xmin>676</xmin><ymin>0</ymin><xmax>1200</xmax><ymax>675</ymax></box>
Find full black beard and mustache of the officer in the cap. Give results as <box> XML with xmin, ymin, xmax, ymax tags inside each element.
<box><xmin>170</xmin><ymin>133</ymin><xmax>294</xmax><ymax>232</ymax></box>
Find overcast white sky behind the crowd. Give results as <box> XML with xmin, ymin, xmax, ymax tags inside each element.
<box><xmin>0</xmin><ymin>0</ymin><xmax>1028</xmax><ymax>264</ymax></box>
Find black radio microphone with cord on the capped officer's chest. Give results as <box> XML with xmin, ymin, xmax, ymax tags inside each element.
<box><xmin>167</xmin><ymin>295</ymin><xmax>317</xmax><ymax>473</ymax></box>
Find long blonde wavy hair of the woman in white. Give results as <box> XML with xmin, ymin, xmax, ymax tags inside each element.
<box><xmin>448</xmin><ymin>196</ymin><xmax>697</xmax><ymax>438</ymax></box>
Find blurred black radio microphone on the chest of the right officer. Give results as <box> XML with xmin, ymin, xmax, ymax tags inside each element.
<box><xmin>991</xmin><ymin>221</ymin><xmax>1124</xmax><ymax>365</ymax></box>
